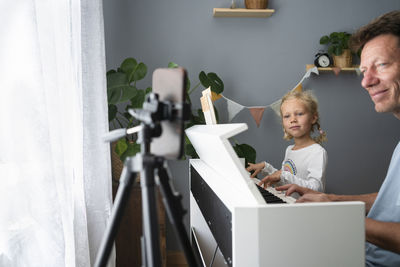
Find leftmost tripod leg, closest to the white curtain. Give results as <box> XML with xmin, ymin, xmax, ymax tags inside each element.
<box><xmin>94</xmin><ymin>159</ymin><xmax>136</xmax><ymax>267</ymax></box>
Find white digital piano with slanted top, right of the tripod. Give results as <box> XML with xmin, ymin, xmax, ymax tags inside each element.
<box><xmin>186</xmin><ymin>123</ymin><xmax>365</xmax><ymax>267</ymax></box>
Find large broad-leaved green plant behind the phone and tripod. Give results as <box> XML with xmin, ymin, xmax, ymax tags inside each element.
<box><xmin>107</xmin><ymin>58</ymin><xmax>256</xmax><ymax>169</ymax></box>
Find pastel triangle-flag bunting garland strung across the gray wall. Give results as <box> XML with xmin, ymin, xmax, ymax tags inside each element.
<box><xmin>212</xmin><ymin>67</ymin><xmax>319</xmax><ymax>127</ymax></box>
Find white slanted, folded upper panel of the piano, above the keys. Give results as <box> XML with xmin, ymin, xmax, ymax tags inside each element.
<box><xmin>186</xmin><ymin>123</ymin><xmax>265</xmax><ymax>206</ymax></box>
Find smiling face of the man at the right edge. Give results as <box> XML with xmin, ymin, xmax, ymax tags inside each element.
<box><xmin>360</xmin><ymin>34</ymin><xmax>400</xmax><ymax>119</ymax></box>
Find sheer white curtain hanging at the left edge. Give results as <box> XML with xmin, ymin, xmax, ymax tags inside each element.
<box><xmin>0</xmin><ymin>0</ymin><xmax>113</xmax><ymax>267</ymax></box>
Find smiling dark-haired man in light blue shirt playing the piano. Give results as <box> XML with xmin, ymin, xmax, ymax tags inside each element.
<box><xmin>277</xmin><ymin>11</ymin><xmax>400</xmax><ymax>266</ymax></box>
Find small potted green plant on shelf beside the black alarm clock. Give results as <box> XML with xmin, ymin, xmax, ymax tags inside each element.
<box><xmin>319</xmin><ymin>32</ymin><xmax>353</xmax><ymax>68</ymax></box>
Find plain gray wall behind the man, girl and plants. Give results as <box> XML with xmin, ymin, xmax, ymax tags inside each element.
<box><xmin>104</xmin><ymin>0</ymin><xmax>400</xmax><ymax>251</ymax></box>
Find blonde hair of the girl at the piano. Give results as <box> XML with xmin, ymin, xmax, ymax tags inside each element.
<box><xmin>280</xmin><ymin>90</ymin><xmax>327</xmax><ymax>144</ymax></box>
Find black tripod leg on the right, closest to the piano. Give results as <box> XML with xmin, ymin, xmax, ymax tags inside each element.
<box><xmin>158</xmin><ymin>160</ymin><xmax>201</xmax><ymax>267</ymax></box>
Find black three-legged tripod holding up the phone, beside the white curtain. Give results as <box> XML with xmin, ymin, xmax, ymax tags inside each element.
<box><xmin>94</xmin><ymin>94</ymin><xmax>200</xmax><ymax>267</ymax></box>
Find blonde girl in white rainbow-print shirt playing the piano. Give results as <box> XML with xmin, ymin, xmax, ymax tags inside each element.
<box><xmin>246</xmin><ymin>91</ymin><xmax>327</xmax><ymax>192</ymax></box>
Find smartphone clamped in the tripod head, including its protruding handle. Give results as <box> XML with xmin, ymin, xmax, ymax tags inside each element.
<box><xmin>103</xmin><ymin>68</ymin><xmax>191</xmax><ymax>159</ymax></box>
